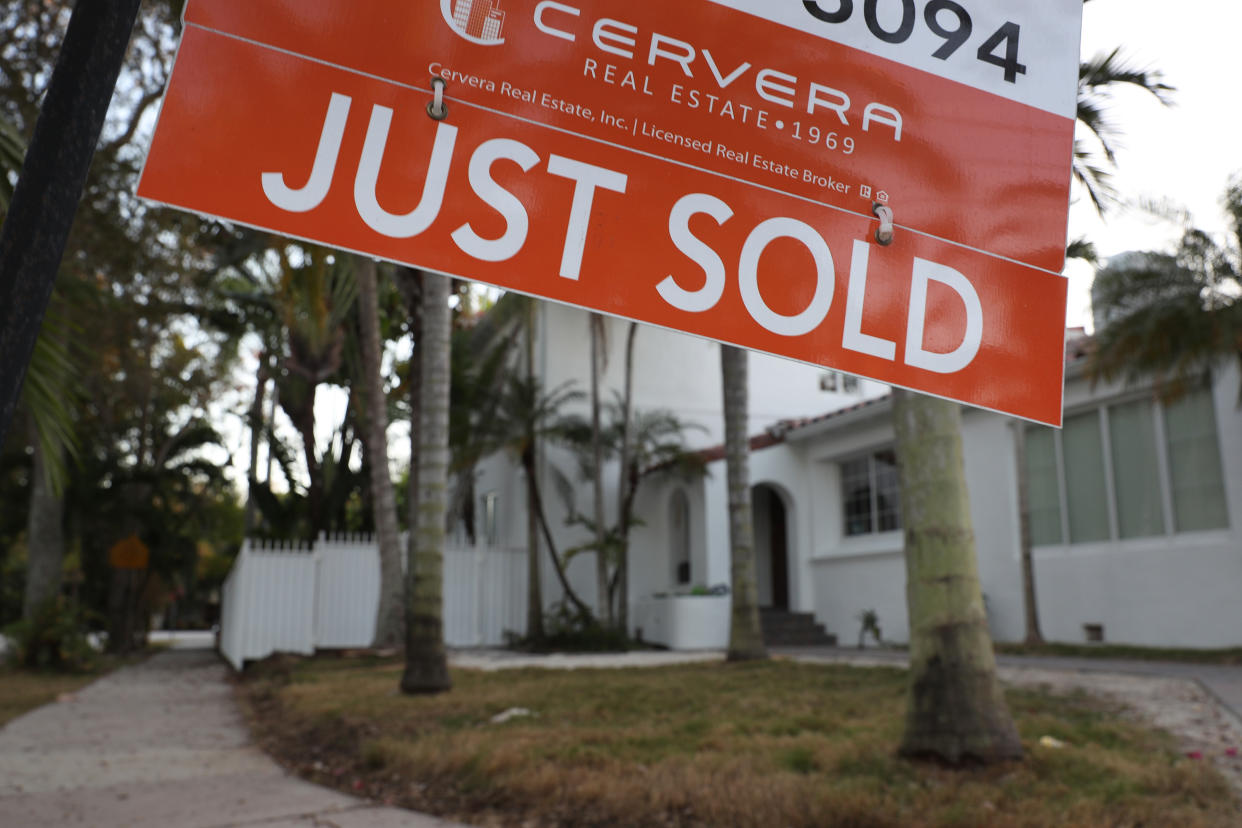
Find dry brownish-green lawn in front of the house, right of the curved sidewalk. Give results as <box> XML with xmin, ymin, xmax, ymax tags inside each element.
<box><xmin>242</xmin><ymin>659</ymin><xmax>1242</xmax><ymax>828</ymax></box>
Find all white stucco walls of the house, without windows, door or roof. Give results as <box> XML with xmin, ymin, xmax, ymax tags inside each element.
<box><xmin>478</xmin><ymin>305</ymin><xmax>1242</xmax><ymax>647</ymax></box>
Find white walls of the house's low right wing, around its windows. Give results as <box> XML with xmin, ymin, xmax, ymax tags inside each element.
<box><xmin>751</xmin><ymin>362</ymin><xmax>1242</xmax><ymax>647</ymax></box>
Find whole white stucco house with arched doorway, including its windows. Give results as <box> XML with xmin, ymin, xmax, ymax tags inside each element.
<box><xmin>466</xmin><ymin>304</ymin><xmax>1242</xmax><ymax>647</ymax></box>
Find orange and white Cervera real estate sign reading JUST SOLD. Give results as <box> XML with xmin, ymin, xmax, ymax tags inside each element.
<box><xmin>139</xmin><ymin>0</ymin><xmax>1081</xmax><ymax>423</ymax></box>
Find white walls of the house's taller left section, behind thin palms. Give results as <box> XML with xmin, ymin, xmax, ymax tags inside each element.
<box><xmin>494</xmin><ymin>303</ymin><xmax>882</xmax><ymax>625</ymax></box>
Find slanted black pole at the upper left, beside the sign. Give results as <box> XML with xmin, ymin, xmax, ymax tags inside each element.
<box><xmin>0</xmin><ymin>0</ymin><xmax>140</xmax><ymax>442</ymax></box>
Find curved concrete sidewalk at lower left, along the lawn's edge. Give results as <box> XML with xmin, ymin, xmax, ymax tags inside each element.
<box><xmin>0</xmin><ymin>648</ymin><xmax>466</xmax><ymax>828</ymax></box>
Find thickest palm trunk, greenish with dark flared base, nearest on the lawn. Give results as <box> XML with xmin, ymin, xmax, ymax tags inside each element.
<box><xmin>893</xmin><ymin>390</ymin><xmax>1022</xmax><ymax>765</ymax></box>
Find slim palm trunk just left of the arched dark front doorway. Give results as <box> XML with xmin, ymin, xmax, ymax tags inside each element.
<box><xmin>720</xmin><ymin>345</ymin><xmax>768</xmax><ymax>662</ymax></box>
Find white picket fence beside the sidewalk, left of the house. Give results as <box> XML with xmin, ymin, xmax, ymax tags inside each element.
<box><xmin>220</xmin><ymin>535</ymin><xmax>527</xmax><ymax>670</ymax></box>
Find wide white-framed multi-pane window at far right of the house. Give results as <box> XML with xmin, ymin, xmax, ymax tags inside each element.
<box><xmin>1026</xmin><ymin>384</ymin><xmax>1228</xmax><ymax>546</ymax></box>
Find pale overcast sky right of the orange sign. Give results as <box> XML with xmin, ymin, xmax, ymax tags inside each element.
<box><xmin>1067</xmin><ymin>0</ymin><xmax>1242</xmax><ymax>326</ymax></box>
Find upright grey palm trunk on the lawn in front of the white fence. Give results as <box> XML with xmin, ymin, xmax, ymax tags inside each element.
<box><xmin>401</xmin><ymin>273</ymin><xmax>452</xmax><ymax>693</ymax></box>
